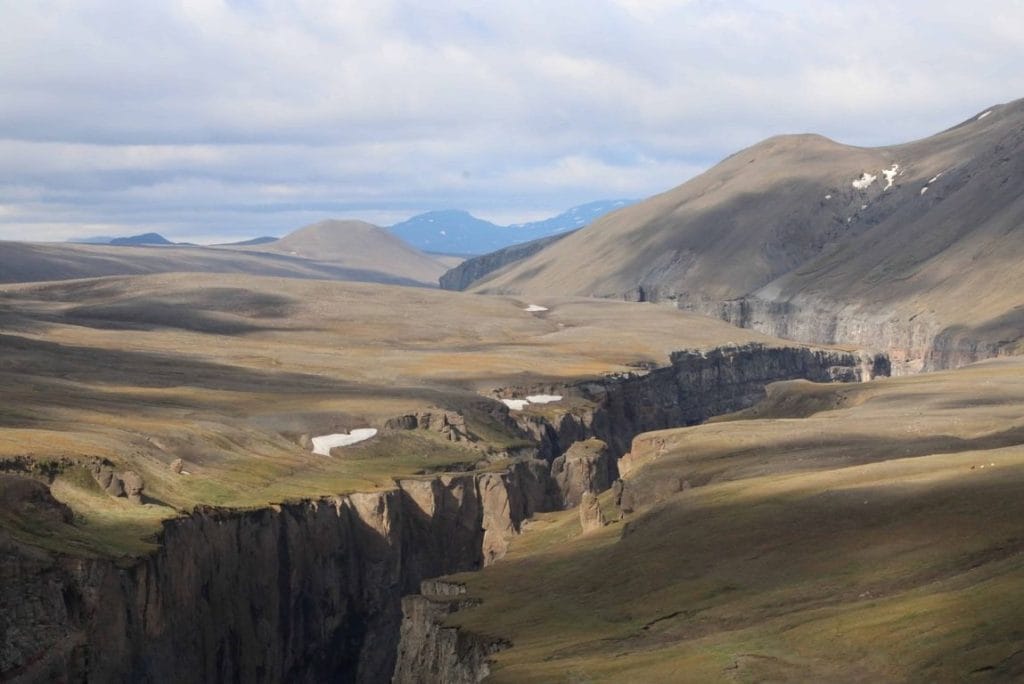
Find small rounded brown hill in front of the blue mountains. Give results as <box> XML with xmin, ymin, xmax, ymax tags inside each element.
<box><xmin>240</xmin><ymin>220</ymin><xmax>447</xmax><ymax>285</ymax></box>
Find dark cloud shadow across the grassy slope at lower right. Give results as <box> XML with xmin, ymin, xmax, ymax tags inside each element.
<box><xmin>483</xmin><ymin>470</ymin><xmax>1024</xmax><ymax>681</ymax></box>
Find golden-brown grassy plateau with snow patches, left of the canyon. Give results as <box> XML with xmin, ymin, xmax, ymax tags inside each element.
<box><xmin>0</xmin><ymin>273</ymin><xmax>768</xmax><ymax>554</ymax></box>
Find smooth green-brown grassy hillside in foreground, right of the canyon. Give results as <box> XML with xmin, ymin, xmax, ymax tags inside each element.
<box><xmin>453</xmin><ymin>359</ymin><xmax>1024</xmax><ymax>682</ymax></box>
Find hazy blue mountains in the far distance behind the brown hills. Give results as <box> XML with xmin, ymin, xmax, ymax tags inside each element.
<box><xmin>390</xmin><ymin>200</ymin><xmax>632</xmax><ymax>255</ymax></box>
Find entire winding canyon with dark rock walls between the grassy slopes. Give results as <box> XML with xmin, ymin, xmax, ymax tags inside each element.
<box><xmin>0</xmin><ymin>345</ymin><xmax>885</xmax><ymax>682</ymax></box>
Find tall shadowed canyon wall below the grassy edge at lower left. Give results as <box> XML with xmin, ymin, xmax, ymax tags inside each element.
<box><xmin>0</xmin><ymin>471</ymin><xmax>548</xmax><ymax>682</ymax></box>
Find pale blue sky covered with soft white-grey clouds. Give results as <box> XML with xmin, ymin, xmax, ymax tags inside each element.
<box><xmin>0</xmin><ymin>0</ymin><xmax>1024</xmax><ymax>243</ymax></box>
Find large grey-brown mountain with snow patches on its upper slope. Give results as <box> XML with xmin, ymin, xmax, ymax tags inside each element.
<box><xmin>475</xmin><ymin>100</ymin><xmax>1024</xmax><ymax>373</ymax></box>
